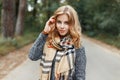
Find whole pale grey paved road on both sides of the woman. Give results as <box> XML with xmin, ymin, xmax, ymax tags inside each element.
<box><xmin>2</xmin><ymin>37</ymin><xmax>120</xmax><ymax>80</ymax></box>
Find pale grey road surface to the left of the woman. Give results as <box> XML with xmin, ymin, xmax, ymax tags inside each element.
<box><xmin>2</xmin><ymin>59</ymin><xmax>39</xmax><ymax>80</ymax></box>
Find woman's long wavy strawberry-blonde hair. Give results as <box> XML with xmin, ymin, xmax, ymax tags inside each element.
<box><xmin>47</xmin><ymin>5</ymin><xmax>81</xmax><ymax>48</ymax></box>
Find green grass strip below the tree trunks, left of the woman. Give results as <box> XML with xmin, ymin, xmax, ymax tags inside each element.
<box><xmin>0</xmin><ymin>33</ymin><xmax>38</xmax><ymax>56</ymax></box>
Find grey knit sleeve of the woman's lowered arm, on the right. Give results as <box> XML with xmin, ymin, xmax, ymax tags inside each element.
<box><xmin>75</xmin><ymin>47</ymin><xmax>86</xmax><ymax>80</ymax></box>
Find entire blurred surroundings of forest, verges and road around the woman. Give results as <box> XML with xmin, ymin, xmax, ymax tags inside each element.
<box><xmin>0</xmin><ymin>0</ymin><xmax>120</xmax><ymax>80</ymax></box>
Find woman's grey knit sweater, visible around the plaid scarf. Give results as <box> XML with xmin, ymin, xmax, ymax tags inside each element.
<box><xmin>28</xmin><ymin>33</ymin><xmax>86</xmax><ymax>80</ymax></box>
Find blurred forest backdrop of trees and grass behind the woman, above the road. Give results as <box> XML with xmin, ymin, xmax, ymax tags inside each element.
<box><xmin>0</xmin><ymin>0</ymin><xmax>120</xmax><ymax>56</ymax></box>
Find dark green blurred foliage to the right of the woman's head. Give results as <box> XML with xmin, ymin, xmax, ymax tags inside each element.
<box><xmin>67</xmin><ymin>0</ymin><xmax>120</xmax><ymax>36</ymax></box>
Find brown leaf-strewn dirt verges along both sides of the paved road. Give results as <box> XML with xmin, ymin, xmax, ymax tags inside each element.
<box><xmin>0</xmin><ymin>36</ymin><xmax>120</xmax><ymax>80</ymax></box>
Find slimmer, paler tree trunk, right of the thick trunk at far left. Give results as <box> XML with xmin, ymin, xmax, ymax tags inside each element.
<box><xmin>15</xmin><ymin>0</ymin><xmax>26</xmax><ymax>35</ymax></box>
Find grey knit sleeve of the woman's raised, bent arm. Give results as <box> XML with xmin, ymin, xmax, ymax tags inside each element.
<box><xmin>28</xmin><ymin>33</ymin><xmax>47</xmax><ymax>61</ymax></box>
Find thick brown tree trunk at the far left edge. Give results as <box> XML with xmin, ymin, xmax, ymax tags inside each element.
<box><xmin>1</xmin><ymin>0</ymin><xmax>15</xmax><ymax>38</ymax></box>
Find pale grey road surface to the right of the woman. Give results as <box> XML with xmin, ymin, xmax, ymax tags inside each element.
<box><xmin>84</xmin><ymin>40</ymin><xmax>120</xmax><ymax>80</ymax></box>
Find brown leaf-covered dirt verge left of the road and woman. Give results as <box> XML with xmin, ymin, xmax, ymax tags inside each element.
<box><xmin>0</xmin><ymin>44</ymin><xmax>32</xmax><ymax>80</ymax></box>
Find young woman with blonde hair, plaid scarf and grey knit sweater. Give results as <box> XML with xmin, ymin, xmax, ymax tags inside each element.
<box><xmin>29</xmin><ymin>5</ymin><xmax>86</xmax><ymax>80</ymax></box>
